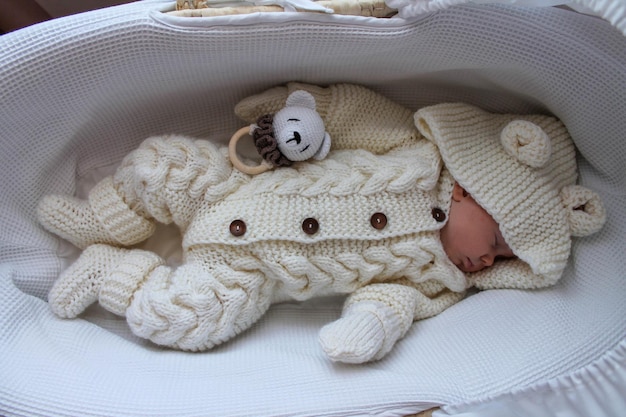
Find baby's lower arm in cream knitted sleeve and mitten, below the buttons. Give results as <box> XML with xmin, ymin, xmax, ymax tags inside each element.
<box><xmin>320</xmin><ymin>280</ymin><xmax>464</xmax><ymax>363</ymax></box>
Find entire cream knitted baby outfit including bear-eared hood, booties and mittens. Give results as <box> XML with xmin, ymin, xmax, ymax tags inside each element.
<box><xmin>38</xmin><ymin>83</ymin><xmax>605</xmax><ymax>363</ymax></box>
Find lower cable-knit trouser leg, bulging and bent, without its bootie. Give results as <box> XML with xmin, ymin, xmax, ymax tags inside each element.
<box><xmin>126</xmin><ymin>250</ymin><xmax>275</xmax><ymax>351</ymax></box>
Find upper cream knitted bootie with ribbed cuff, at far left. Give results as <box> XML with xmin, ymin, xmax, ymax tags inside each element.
<box><xmin>37</xmin><ymin>177</ymin><xmax>155</xmax><ymax>249</ymax></box>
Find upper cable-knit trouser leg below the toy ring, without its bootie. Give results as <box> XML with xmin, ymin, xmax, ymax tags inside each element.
<box><xmin>113</xmin><ymin>136</ymin><xmax>246</xmax><ymax>229</ymax></box>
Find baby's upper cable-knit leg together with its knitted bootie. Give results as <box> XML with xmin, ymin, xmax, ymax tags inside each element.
<box><xmin>38</xmin><ymin>136</ymin><xmax>243</xmax><ymax>249</ymax></box>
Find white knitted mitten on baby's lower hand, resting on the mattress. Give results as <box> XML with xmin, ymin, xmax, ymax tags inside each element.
<box><xmin>320</xmin><ymin>301</ymin><xmax>405</xmax><ymax>363</ymax></box>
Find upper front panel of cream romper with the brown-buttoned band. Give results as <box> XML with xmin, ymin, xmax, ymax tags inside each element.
<box><xmin>183</xmin><ymin>141</ymin><xmax>449</xmax><ymax>248</ymax></box>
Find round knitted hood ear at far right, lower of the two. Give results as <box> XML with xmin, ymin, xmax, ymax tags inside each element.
<box><xmin>561</xmin><ymin>185</ymin><xmax>606</xmax><ymax>236</ymax></box>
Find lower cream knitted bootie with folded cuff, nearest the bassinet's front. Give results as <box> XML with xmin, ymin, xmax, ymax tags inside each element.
<box><xmin>48</xmin><ymin>245</ymin><xmax>163</xmax><ymax>318</ymax></box>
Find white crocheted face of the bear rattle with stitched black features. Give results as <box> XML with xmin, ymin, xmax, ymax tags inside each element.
<box><xmin>274</xmin><ymin>106</ymin><xmax>326</xmax><ymax>161</ymax></box>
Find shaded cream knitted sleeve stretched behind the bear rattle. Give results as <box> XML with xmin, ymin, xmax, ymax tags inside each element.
<box><xmin>235</xmin><ymin>83</ymin><xmax>422</xmax><ymax>154</ymax></box>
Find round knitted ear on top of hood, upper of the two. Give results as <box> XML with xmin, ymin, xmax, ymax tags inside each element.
<box><xmin>500</xmin><ymin>120</ymin><xmax>552</xmax><ymax>168</ymax></box>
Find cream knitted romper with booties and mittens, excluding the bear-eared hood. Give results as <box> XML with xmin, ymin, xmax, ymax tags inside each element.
<box><xmin>39</xmin><ymin>84</ymin><xmax>467</xmax><ymax>362</ymax></box>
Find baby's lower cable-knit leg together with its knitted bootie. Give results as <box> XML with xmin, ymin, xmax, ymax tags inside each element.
<box><xmin>49</xmin><ymin>245</ymin><xmax>275</xmax><ymax>351</ymax></box>
